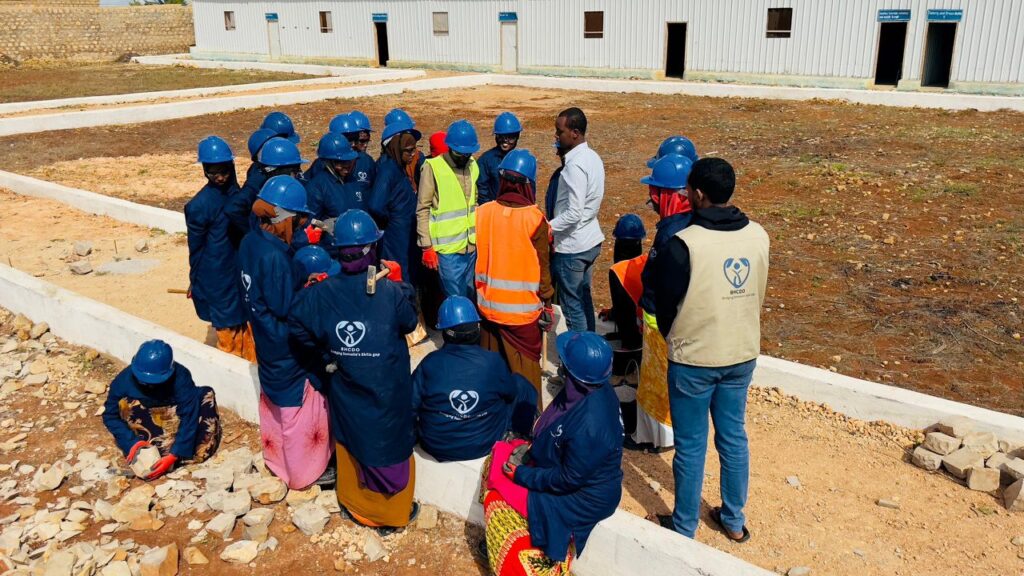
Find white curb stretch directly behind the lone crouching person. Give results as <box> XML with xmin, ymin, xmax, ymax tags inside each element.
<box><xmin>0</xmin><ymin>264</ymin><xmax>259</xmax><ymax>422</ymax></box>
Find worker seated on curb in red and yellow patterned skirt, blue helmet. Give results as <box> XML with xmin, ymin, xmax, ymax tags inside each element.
<box><xmin>483</xmin><ymin>332</ymin><xmax>623</xmax><ymax>576</ymax></box>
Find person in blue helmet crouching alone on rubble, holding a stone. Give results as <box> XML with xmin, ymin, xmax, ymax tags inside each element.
<box><xmin>103</xmin><ymin>340</ymin><xmax>220</xmax><ymax>480</ymax></box>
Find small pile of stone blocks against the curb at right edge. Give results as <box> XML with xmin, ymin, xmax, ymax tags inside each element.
<box><xmin>910</xmin><ymin>416</ymin><xmax>1024</xmax><ymax>511</ymax></box>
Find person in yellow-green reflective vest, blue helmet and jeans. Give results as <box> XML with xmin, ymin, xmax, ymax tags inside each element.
<box><xmin>416</xmin><ymin>120</ymin><xmax>480</xmax><ymax>300</ymax></box>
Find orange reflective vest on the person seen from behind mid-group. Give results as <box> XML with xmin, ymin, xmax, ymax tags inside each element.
<box><xmin>476</xmin><ymin>202</ymin><xmax>544</xmax><ymax>326</ymax></box>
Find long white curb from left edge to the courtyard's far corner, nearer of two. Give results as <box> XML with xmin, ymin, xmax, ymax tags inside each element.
<box><xmin>0</xmin><ymin>76</ymin><xmax>487</xmax><ymax>136</ymax></box>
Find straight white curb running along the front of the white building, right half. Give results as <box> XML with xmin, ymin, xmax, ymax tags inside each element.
<box><xmin>489</xmin><ymin>74</ymin><xmax>1024</xmax><ymax>112</ymax></box>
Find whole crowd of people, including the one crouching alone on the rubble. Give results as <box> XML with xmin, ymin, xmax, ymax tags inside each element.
<box><xmin>103</xmin><ymin>108</ymin><xmax>768</xmax><ymax>575</ymax></box>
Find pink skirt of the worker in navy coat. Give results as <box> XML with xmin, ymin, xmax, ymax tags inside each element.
<box><xmin>259</xmin><ymin>380</ymin><xmax>334</xmax><ymax>490</ymax></box>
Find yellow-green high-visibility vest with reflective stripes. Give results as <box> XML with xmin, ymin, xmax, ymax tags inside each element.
<box><xmin>427</xmin><ymin>156</ymin><xmax>480</xmax><ymax>254</ymax></box>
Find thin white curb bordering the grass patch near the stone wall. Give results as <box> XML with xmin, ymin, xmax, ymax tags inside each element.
<box><xmin>0</xmin><ymin>70</ymin><xmax>426</xmax><ymax>116</ymax></box>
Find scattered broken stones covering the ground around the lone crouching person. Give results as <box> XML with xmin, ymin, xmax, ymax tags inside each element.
<box><xmin>0</xmin><ymin>311</ymin><xmax>449</xmax><ymax>576</ymax></box>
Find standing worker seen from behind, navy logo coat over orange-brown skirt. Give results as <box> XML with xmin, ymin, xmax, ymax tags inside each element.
<box><xmin>288</xmin><ymin>210</ymin><xmax>418</xmax><ymax>534</ymax></box>
